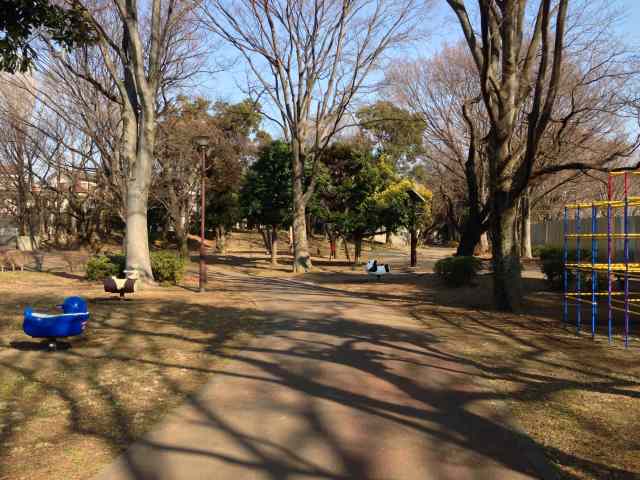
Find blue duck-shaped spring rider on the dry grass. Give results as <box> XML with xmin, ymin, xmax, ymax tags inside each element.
<box><xmin>22</xmin><ymin>297</ymin><xmax>89</xmax><ymax>350</ymax></box>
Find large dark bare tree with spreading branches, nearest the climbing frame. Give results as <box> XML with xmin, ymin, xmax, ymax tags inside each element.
<box><xmin>430</xmin><ymin>0</ymin><xmax>640</xmax><ymax>310</ymax></box>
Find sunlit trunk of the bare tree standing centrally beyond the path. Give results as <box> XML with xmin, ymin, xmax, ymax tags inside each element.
<box><xmin>292</xmin><ymin>139</ymin><xmax>311</xmax><ymax>273</ymax></box>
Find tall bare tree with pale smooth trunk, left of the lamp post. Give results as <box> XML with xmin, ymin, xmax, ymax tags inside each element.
<box><xmin>42</xmin><ymin>0</ymin><xmax>208</xmax><ymax>280</ymax></box>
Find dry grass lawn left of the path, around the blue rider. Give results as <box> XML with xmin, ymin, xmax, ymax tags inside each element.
<box><xmin>0</xmin><ymin>272</ymin><xmax>262</xmax><ymax>480</ymax></box>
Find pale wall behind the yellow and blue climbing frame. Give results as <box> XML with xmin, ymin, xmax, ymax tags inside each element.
<box><xmin>531</xmin><ymin>217</ymin><xmax>640</xmax><ymax>261</ymax></box>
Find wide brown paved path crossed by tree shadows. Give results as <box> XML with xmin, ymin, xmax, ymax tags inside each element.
<box><xmin>97</xmin><ymin>276</ymin><xmax>540</xmax><ymax>480</ymax></box>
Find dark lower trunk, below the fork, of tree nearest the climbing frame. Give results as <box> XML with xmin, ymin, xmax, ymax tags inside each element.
<box><xmin>491</xmin><ymin>191</ymin><xmax>522</xmax><ymax>311</ymax></box>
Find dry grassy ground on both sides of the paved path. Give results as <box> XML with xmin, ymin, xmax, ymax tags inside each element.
<box><xmin>0</xmin><ymin>234</ymin><xmax>640</xmax><ymax>480</ymax></box>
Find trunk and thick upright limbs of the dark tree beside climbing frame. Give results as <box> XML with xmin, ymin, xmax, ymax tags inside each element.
<box><xmin>447</xmin><ymin>0</ymin><xmax>569</xmax><ymax>311</ymax></box>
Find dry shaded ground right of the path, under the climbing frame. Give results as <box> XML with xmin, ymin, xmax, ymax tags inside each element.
<box><xmin>302</xmin><ymin>271</ymin><xmax>640</xmax><ymax>479</ymax></box>
